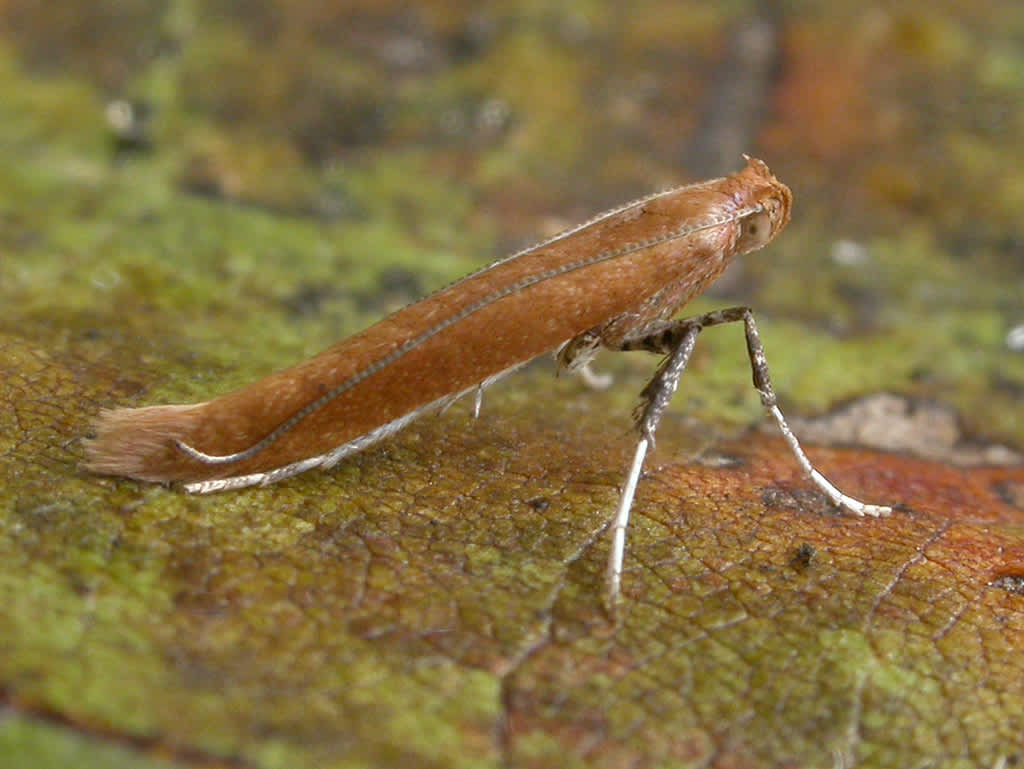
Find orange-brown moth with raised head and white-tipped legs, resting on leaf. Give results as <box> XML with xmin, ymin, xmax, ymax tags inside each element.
<box><xmin>86</xmin><ymin>158</ymin><xmax>891</xmax><ymax>604</ymax></box>
